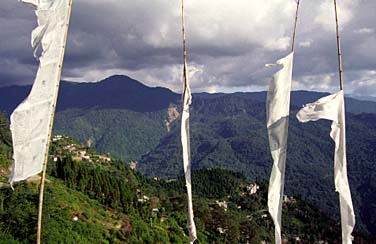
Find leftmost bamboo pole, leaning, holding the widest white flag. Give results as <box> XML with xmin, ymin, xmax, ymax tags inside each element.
<box><xmin>37</xmin><ymin>0</ymin><xmax>73</xmax><ymax>244</ymax></box>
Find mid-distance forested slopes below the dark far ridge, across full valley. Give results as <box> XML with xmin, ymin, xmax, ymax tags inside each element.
<box><xmin>50</xmin><ymin>94</ymin><xmax>376</xmax><ymax>235</ymax></box>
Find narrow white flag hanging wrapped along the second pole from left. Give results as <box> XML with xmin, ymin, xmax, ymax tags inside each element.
<box><xmin>181</xmin><ymin>60</ymin><xmax>197</xmax><ymax>243</ymax></box>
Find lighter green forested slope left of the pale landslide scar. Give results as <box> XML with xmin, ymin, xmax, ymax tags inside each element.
<box><xmin>54</xmin><ymin>109</ymin><xmax>167</xmax><ymax>161</ymax></box>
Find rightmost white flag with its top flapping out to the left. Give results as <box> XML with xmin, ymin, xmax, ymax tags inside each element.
<box><xmin>296</xmin><ymin>90</ymin><xmax>355</xmax><ymax>244</ymax></box>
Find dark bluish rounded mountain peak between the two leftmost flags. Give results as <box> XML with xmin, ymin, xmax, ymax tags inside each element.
<box><xmin>57</xmin><ymin>75</ymin><xmax>180</xmax><ymax>112</ymax></box>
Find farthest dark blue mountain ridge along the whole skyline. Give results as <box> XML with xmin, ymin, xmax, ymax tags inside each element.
<box><xmin>0</xmin><ymin>75</ymin><xmax>376</xmax><ymax>116</ymax></box>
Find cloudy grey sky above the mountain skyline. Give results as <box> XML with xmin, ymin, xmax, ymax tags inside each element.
<box><xmin>0</xmin><ymin>0</ymin><xmax>376</xmax><ymax>96</ymax></box>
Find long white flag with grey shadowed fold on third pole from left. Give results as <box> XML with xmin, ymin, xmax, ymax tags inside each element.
<box><xmin>266</xmin><ymin>52</ymin><xmax>294</xmax><ymax>244</ymax></box>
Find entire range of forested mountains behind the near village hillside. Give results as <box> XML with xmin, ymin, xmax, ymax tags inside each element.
<box><xmin>0</xmin><ymin>76</ymin><xmax>376</xmax><ymax>238</ymax></box>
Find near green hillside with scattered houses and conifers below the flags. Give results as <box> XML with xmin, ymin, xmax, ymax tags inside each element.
<box><xmin>0</xmin><ymin>113</ymin><xmax>370</xmax><ymax>244</ymax></box>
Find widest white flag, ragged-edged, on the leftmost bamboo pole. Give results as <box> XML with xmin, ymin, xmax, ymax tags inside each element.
<box><xmin>9</xmin><ymin>0</ymin><xmax>70</xmax><ymax>184</ymax></box>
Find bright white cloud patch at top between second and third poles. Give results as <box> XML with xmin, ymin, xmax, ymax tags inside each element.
<box><xmin>186</xmin><ymin>0</ymin><xmax>295</xmax><ymax>50</ymax></box>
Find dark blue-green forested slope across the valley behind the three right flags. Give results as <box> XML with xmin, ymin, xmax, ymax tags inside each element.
<box><xmin>139</xmin><ymin>96</ymin><xmax>376</xmax><ymax>236</ymax></box>
